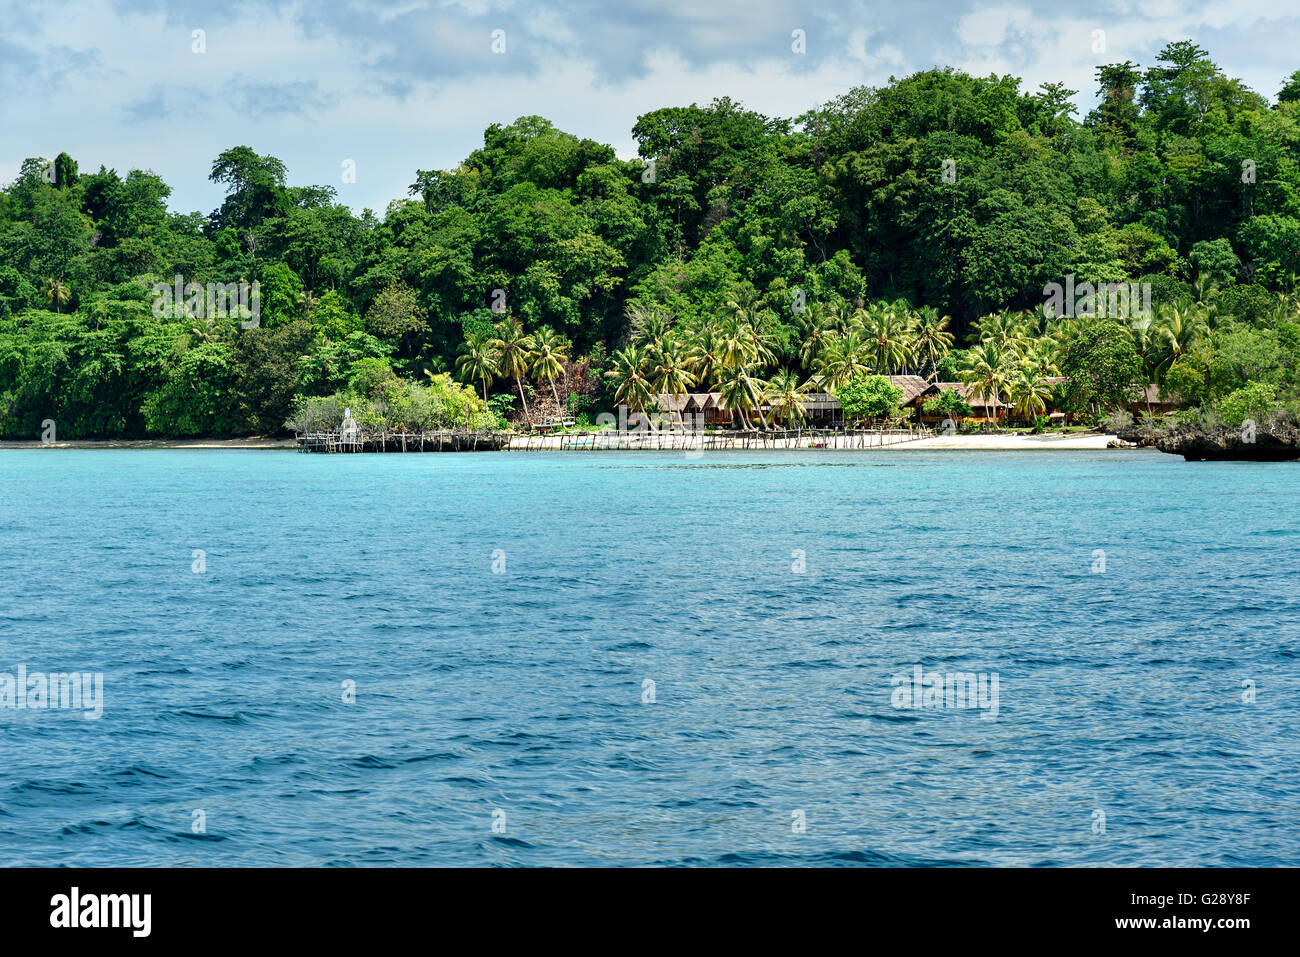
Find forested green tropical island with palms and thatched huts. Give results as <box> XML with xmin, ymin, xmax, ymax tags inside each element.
<box><xmin>0</xmin><ymin>42</ymin><xmax>1300</xmax><ymax>452</ymax></box>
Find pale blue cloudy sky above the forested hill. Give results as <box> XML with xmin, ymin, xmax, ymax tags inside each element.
<box><xmin>0</xmin><ymin>0</ymin><xmax>1300</xmax><ymax>213</ymax></box>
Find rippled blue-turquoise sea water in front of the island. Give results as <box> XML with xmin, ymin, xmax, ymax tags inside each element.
<box><xmin>0</xmin><ymin>450</ymin><xmax>1300</xmax><ymax>866</ymax></box>
